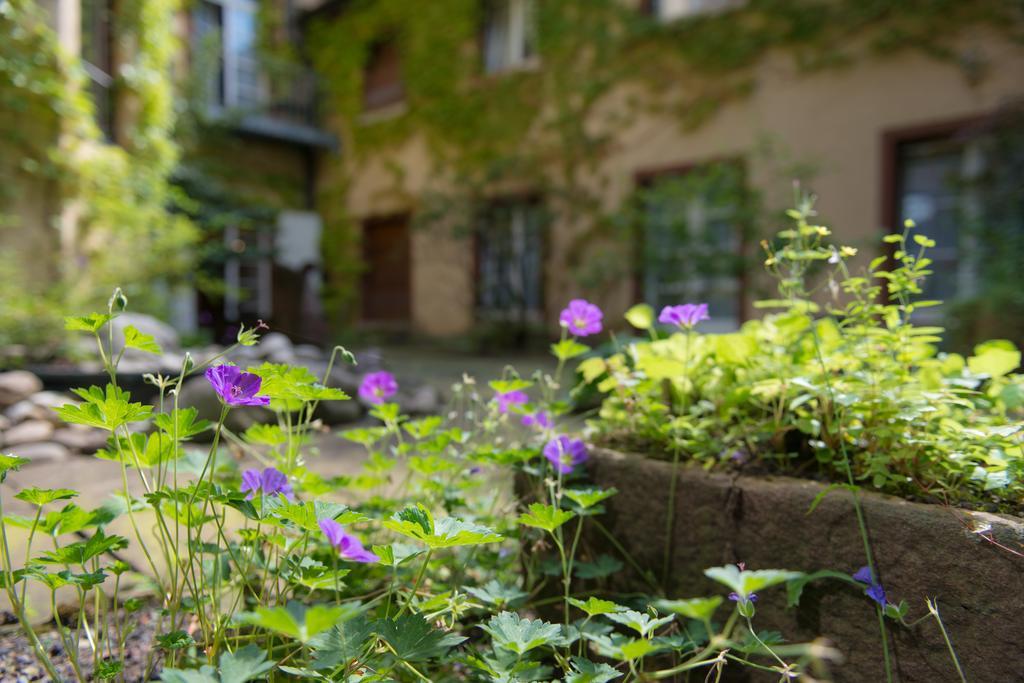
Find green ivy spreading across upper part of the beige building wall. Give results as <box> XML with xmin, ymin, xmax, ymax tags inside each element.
<box><xmin>308</xmin><ymin>0</ymin><xmax>1024</xmax><ymax>325</ymax></box>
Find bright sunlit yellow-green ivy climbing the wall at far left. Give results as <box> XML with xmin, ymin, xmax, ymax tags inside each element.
<box><xmin>0</xmin><ymin>0</ymin><xmax>196</xmax><ymax>360</ymax></box>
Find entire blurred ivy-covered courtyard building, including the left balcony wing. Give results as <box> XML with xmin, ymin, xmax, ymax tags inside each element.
<box><xmin>0</xmin><ymin>0</ymin><xmax>1024</xmax><ymax>360</ymax></box>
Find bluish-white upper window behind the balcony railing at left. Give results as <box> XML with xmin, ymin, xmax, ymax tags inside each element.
<box><xmin>193</xmin><ymin>0</ymin><xmax>266</xmax><ymax>109</ymax></box>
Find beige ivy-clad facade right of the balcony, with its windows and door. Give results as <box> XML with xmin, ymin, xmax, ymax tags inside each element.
<box><xmin>307</xmin><ymin>0</ymin><xmax>1024</xmax><ymax>344</ymax></box>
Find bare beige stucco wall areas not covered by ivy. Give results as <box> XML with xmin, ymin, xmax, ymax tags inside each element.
<box><xmin>331</xmin><ymin>31</ymin><xmax>1024</xmax><ymax>335</ymax></box>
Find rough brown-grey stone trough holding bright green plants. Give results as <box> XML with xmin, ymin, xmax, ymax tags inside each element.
<box><xmin>581</xmin><ymin>450</ymin><xmax>1024</xmax><ymax>683</ymax></box>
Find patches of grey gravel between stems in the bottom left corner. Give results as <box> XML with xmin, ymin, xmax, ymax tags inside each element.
<box><xmin>0</xmin><ymin>611</ymin><xmax>156</xmax><ymax>683</ymax></box>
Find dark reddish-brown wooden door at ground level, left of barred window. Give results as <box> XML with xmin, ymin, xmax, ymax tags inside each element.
<box><xmin>362</xmin><ymin>215</ymin><xmax>412</xmax><ymax>323</ymax></box>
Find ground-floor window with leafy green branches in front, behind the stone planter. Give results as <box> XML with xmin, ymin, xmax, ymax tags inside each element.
<box><xmin>636</xmin><ymin>164</ymin><xmax>746</xmax><ymax>331</ymax></box>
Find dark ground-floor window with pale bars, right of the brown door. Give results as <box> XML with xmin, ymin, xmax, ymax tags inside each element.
<box><xmin>476</xmin><ymin>200</ymin><xmax>544</xmax><ymax>324</ymax></box>
